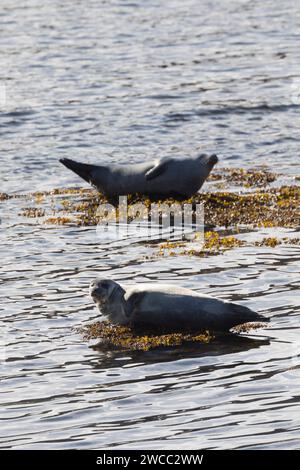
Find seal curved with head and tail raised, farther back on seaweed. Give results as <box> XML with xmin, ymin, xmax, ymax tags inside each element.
<box><xmin>60</xmin><ymin>154</ymin><xmax>218</xmax><ymax>200</ymax></box>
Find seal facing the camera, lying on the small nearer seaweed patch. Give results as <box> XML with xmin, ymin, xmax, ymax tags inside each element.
<box><xmin>90</xmin><ymin>279</ymin><xmax>269</xmax><ymax>331</ymax></box>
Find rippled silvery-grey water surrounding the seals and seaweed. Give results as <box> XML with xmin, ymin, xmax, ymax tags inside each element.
<box><xmin>0</xmin><ymin>0</ymin><xmax>300</xmax><ymax>449</ymax></box>
